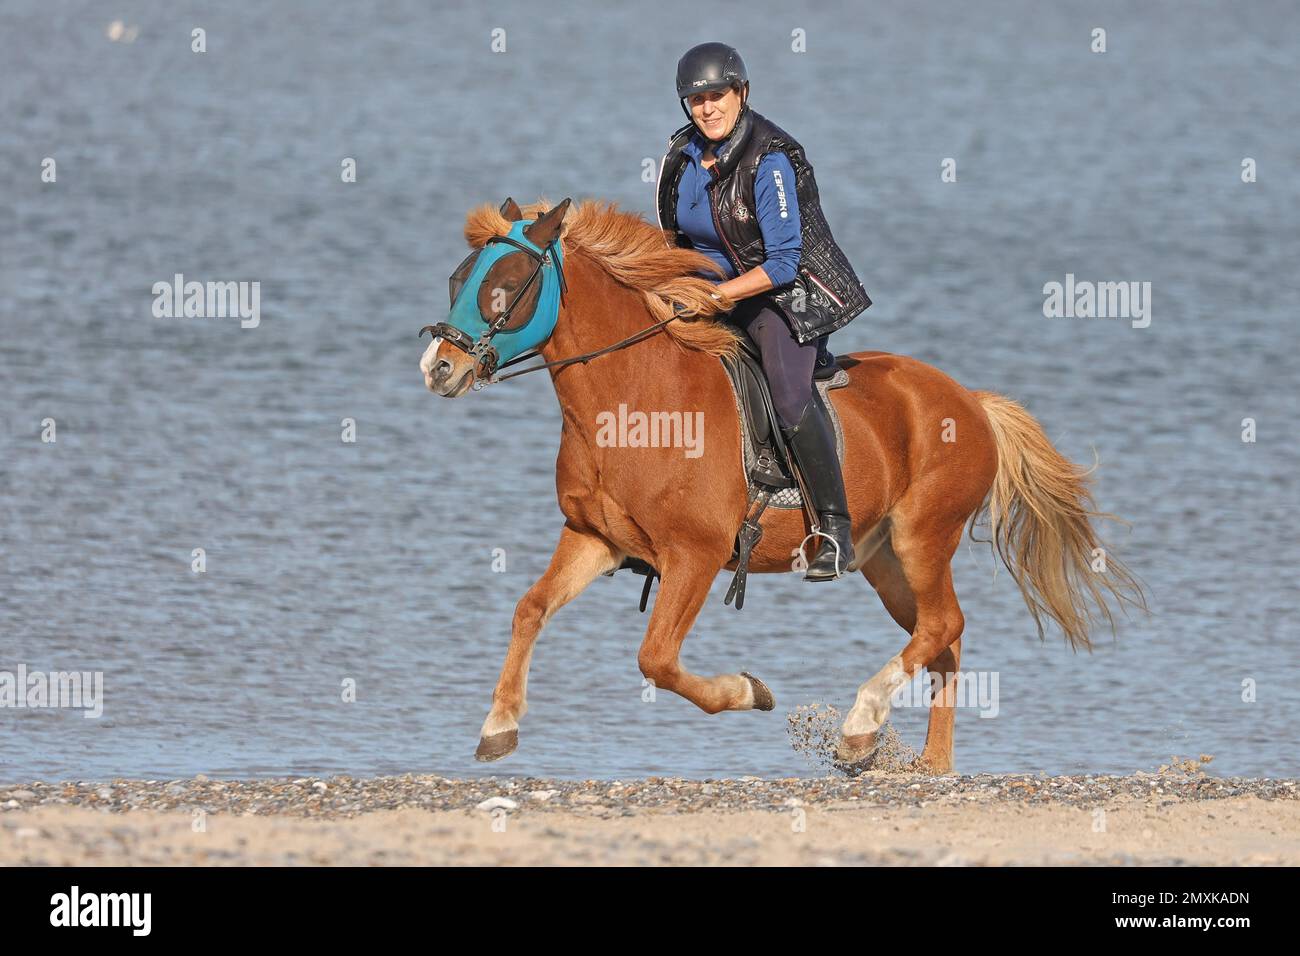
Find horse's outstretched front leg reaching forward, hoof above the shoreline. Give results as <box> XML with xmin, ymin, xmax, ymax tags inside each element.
<box><xmin>475</xmin><ymin>525</ymin><xmax>623</xmax><ymax>761</ymax></box>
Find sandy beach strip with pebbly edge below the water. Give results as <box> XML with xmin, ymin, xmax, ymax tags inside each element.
<box><xmin>0</xmin><ymin>769</ymin><xmax>1300</xmax><ymax>866</ymax></box>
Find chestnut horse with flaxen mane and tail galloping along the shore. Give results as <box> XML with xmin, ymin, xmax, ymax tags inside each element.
<box><xmin>420</xmin><ymin>199</ymin><xmax>1145</xmax><ymax>773</ymax></box>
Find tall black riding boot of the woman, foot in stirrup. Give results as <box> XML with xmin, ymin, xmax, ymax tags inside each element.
<box><xmin>781</xmin><ymin>389</ymin><xmax>854</xmax><ymax>581</ymax></box>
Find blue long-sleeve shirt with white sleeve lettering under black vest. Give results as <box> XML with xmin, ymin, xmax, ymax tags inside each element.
<box><xmin>677</xmin><ymin>133</ymin><xmax>803</xmax><ymax>289</ymax></box>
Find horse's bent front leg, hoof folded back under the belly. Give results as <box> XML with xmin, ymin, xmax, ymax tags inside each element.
<box><xmin>637</xmin><ymin>558</ymin><xmax>776</xmax><ymax>714</ymax></box>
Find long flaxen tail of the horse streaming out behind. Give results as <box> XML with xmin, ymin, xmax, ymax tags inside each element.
<box><xmin>967</xmin><ymin>392</ymin><xmax>1147</xmax><ymax>650</ymax></box>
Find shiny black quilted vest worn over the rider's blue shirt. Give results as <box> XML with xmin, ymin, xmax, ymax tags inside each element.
<box><xmin>657</xmin><ymin>107</ymin><xmax>871</xmax><ymax>342</ymax></box>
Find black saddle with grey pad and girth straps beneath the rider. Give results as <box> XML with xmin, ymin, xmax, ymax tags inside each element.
<box><xmin>606</xmin><ymin>329</ymin><xmax>849</xmax><ymax>613</ymax></box>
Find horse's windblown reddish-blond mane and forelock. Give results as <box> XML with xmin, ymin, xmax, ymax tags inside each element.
<box><xmin>465</xmin><ymin>199</ymin><xmax>738</xmax><ymax>355</ymax></box>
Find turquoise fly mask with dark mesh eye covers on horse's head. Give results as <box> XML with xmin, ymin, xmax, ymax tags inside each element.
<box><xmin>420</xmin><ymin>214</ymin><xmax>567</xmax><ymax>389</ymax></box>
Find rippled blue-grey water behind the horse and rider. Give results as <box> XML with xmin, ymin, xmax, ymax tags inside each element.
<box><xmin>0</xmin><ymin>0</ymin><xmax>1300</xmax><ymax>782</ymax></box>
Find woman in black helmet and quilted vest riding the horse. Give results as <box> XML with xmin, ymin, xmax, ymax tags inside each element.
<box><xmin>657</xmin><ymin>43</ymin><xmax>871</xmax><ymax>581</ymax></box>
